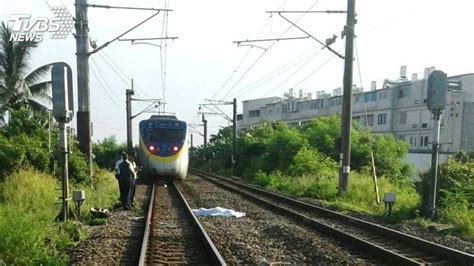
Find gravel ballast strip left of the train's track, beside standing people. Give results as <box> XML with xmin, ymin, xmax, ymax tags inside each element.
<box><xmin>68</xmin><ymin>185</ymin><xmax>149</xmax><ymax>265</ymax></box>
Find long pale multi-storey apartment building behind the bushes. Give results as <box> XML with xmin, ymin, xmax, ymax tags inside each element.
<box><xmin>238</xmin><ymin>67</ymin><xmax>474</xmax><ymax>153</ymax></box>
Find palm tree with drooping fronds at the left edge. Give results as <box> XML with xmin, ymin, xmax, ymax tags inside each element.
<box><xmin>0</xmin><ymin>22</ymin><xmax>51</xmax><ymax>117</ymax></box>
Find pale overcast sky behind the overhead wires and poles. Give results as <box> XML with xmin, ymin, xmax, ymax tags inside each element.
<box><xmin>0</xmin><ymin>0</ymin><xmax>474</xmax><ymax>143</ymax></box>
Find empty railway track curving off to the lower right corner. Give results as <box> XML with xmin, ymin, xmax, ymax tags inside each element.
<box><xmin>190</xmin><ymin>169</ymin><xmax>474</xmax><ymax>265</ymax></box>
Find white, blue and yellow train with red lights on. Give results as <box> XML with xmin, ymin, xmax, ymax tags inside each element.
<box><xmin>138</xmin><ymin>115</ymin><xmax>189</xmax><ymax>180</ymax></box>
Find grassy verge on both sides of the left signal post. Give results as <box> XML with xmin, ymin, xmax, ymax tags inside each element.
<box><xmin>0</xmin><ymin>167</ymin><xmax>118</xmax><ymax>265</ymax></box>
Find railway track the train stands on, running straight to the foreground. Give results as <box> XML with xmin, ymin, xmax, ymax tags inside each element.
<box><xmin>139</xmin><ymin>182</ymin><xmax>225</xmax><ymax>265</ymax></box>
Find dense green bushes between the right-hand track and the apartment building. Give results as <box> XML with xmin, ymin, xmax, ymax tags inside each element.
<box><xmin>191</xmin><ymin>115</ymin><xmax>411</xmax><ymax>182</ymax></box>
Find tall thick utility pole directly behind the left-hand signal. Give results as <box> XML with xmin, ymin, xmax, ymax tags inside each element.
<box><xmin>75</xmin><ymin>0</ymin><xmax>92</xmax><ymax>172</ymax></box>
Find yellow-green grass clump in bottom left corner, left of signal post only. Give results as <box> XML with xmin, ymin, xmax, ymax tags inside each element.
<box><xmin>0</xmin><ymin>170</ymin><xmax>66</xmax><ymax>264</ymax></box>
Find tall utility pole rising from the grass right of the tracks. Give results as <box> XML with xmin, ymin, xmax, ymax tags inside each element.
<box><xmin>338</xmin><ymin>0</ymin><xmax>356</xmax><ymax>193</ymax></box>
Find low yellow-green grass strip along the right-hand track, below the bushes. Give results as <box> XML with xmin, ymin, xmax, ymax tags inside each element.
<box><xmin>251</xmin><ymin>172</ymin><xmax>420</xmax><ymax>219</ymax></box>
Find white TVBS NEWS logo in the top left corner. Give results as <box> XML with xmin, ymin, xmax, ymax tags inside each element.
<box><xmin>8</xmin><ymin>6</ymin><xmax>74</xmax><ymax>42</ymax></box>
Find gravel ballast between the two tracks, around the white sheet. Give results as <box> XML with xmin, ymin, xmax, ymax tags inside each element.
<box><xmin>178</xmin><ymin>178</ymin><xmax>373</xmax><ymax>264</ymax></box>
